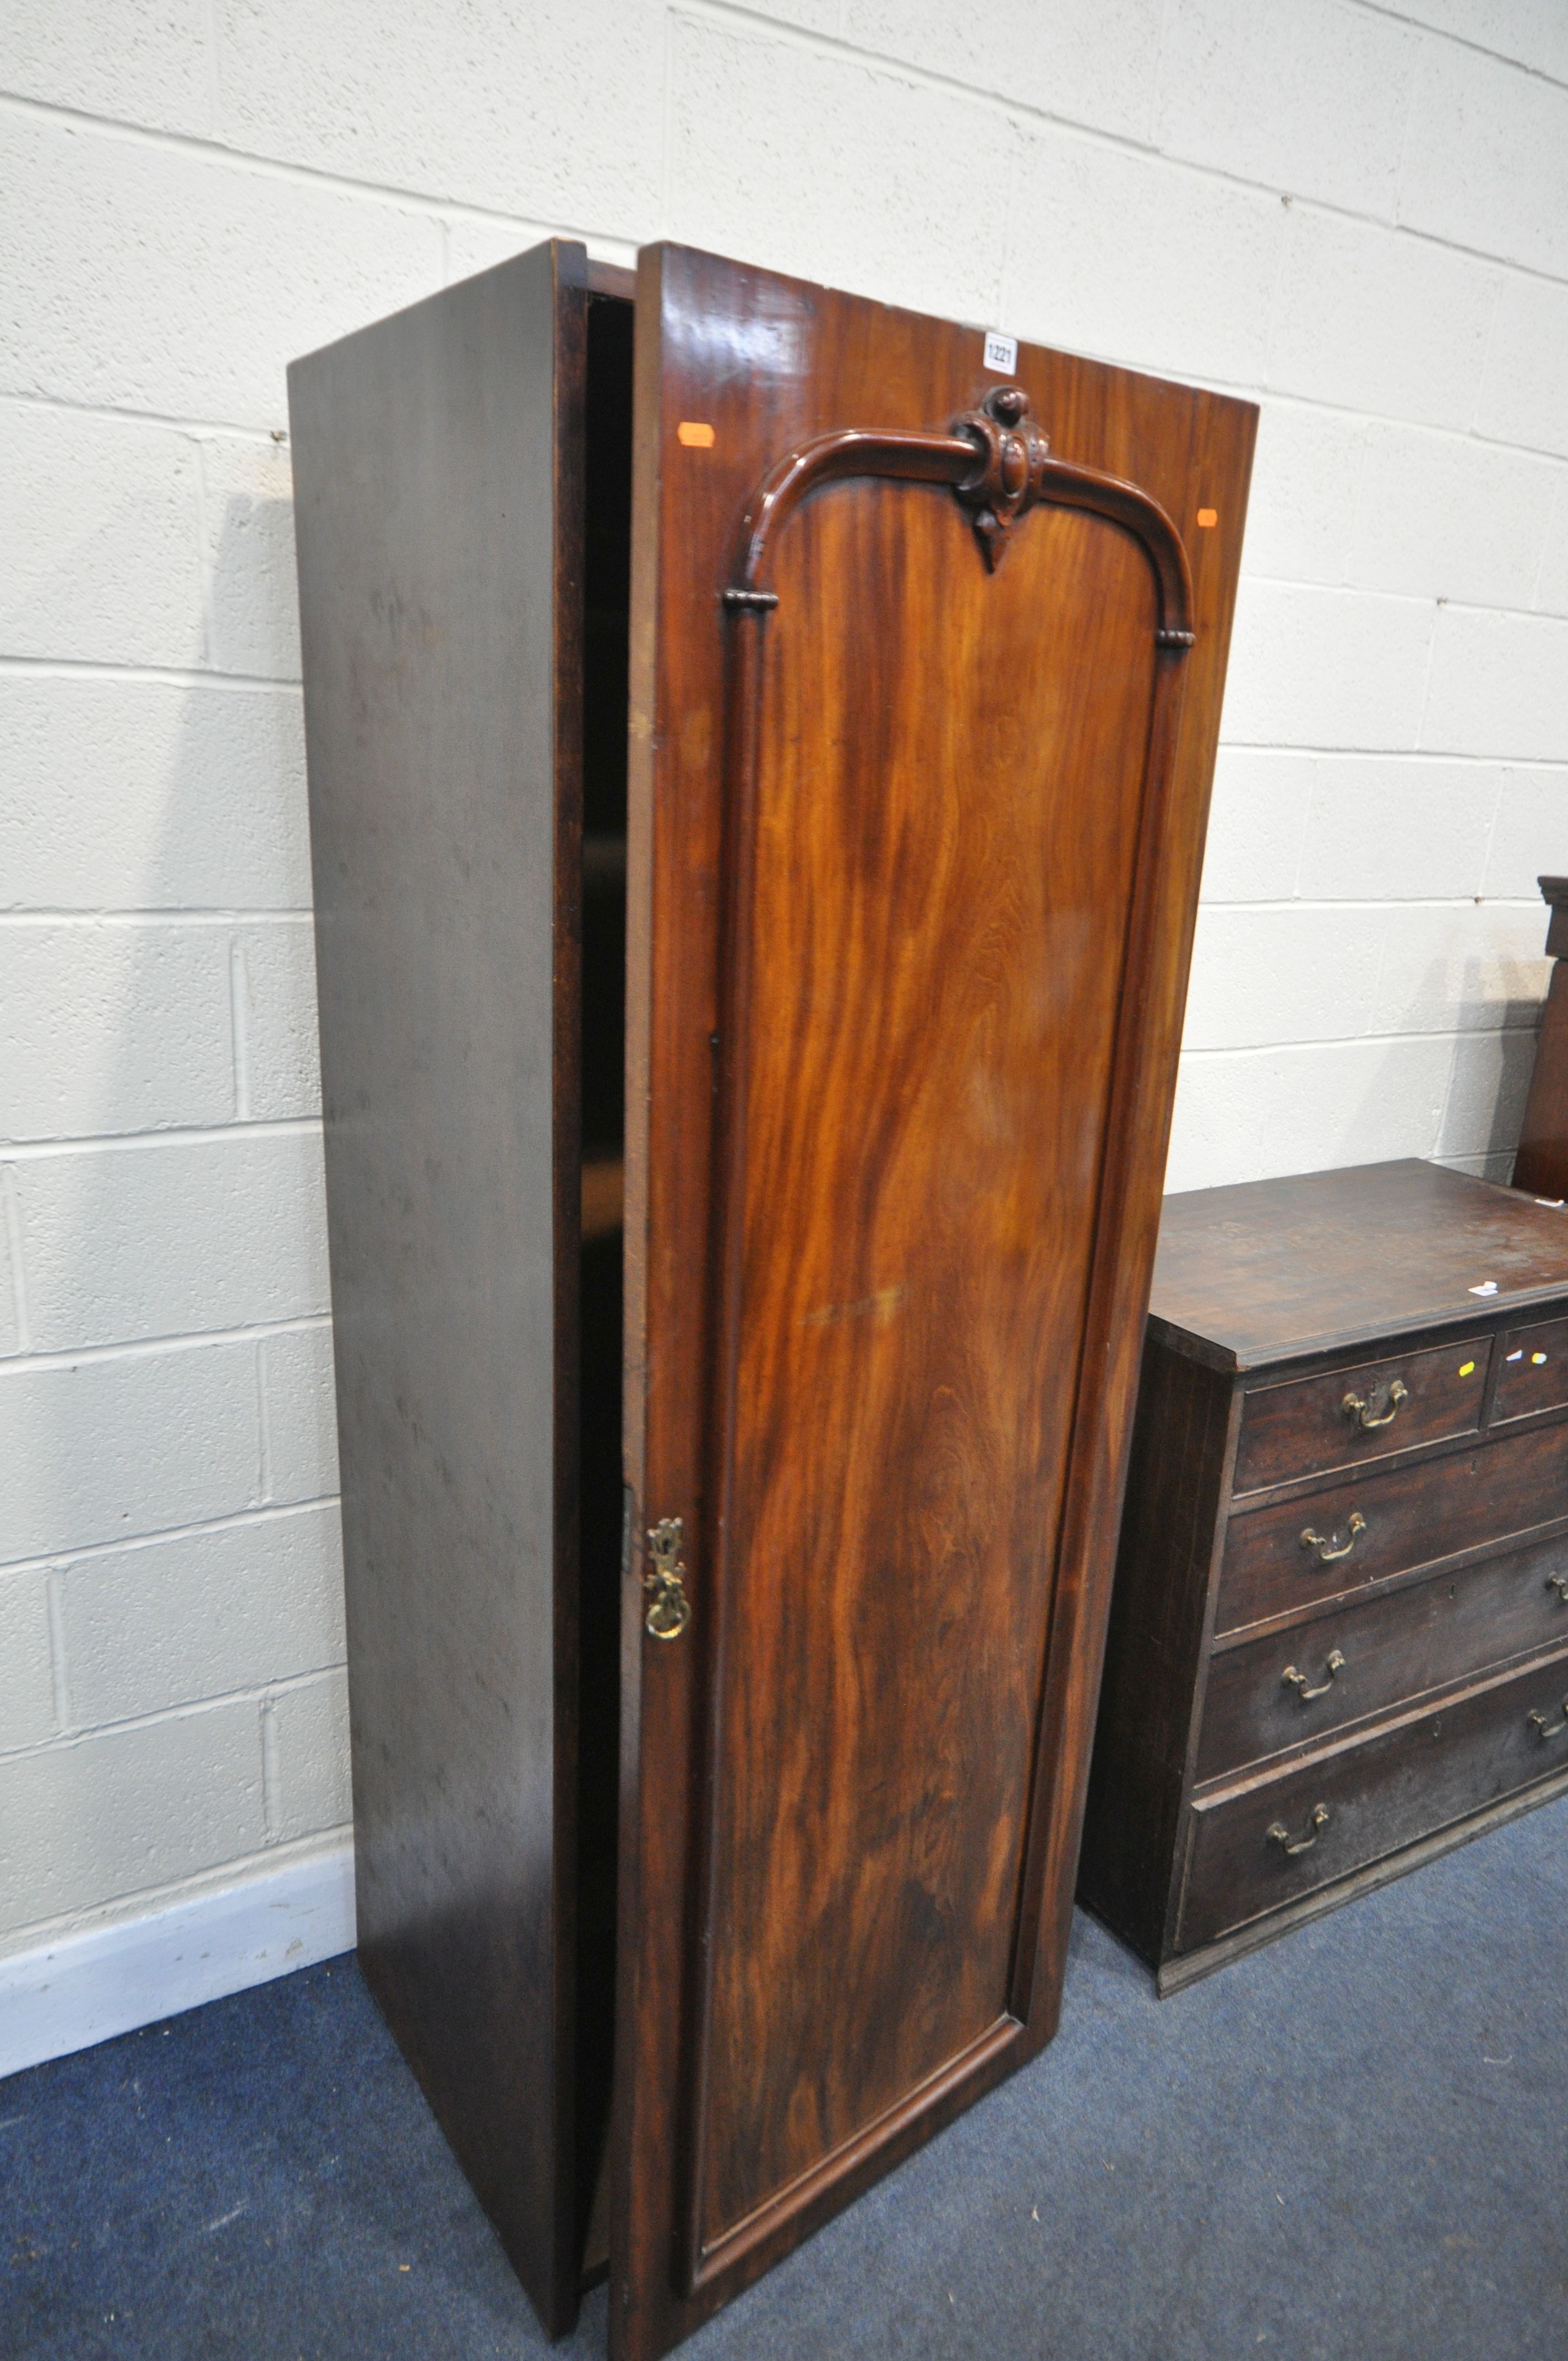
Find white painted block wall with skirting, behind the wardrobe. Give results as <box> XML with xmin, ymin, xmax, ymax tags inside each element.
<box><xmin>0</xmin><ymin>0</ymin><xmax>1568</xmax><ymax>2066</ymax></box>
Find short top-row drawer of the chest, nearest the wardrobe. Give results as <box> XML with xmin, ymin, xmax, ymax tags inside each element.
<box><xmin>1233</xmin><ymin>1336</ymin><xmax>1483</xmax><ymax>1492</ymax></box>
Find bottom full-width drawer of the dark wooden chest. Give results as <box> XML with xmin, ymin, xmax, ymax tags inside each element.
<box><xmin>1176</xmin><ymin>1653</ymin><xmax>1568</xmax><ymax>1952</ymax></box>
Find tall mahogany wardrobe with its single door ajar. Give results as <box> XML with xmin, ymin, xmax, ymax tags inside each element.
<box><xmin>291</xmin><ymin>243</ymin><xmax>1256</xmax><ymax>2356</ymax></box>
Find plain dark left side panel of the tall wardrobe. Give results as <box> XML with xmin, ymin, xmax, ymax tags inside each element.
<box><xmin>291</xmin><ymin>243</ymin><xmax>588</xmax><ymax>2330</ymax></box>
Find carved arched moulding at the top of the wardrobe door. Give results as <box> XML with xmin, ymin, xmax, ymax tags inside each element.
<box><xmin>722</xmin><ymin>385</ymin><xmax>1193</xmax><ymax>649</ymax></box>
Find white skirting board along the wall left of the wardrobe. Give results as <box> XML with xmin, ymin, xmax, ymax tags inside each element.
<box><xmin>0</xmin><ymin>1844</ymin><xmax>354</xmax><ymax>2075</ymax></box>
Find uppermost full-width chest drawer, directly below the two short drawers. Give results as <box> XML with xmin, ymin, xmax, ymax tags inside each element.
<box><xmin>1216</xmin><ymin>1426</ymin><xmax>1568</xmax><ymax>1631</ymax></box>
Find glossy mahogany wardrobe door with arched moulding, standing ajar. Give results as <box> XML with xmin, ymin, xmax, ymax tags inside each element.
<box><xmin>612</xmin><ymin>248</ymin><xmax>1256</xmax><ymax>2356</ymax></box>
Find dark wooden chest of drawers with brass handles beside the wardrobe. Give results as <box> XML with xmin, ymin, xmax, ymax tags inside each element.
<box><xmin>1079</xmin><ymin>1162</ymin><xmax>1568</xmax><ymax>1993</ymax></box>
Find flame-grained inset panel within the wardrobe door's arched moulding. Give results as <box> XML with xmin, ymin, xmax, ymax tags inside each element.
<box><xmin>699</xmin><ymin>484</ymin><xmax>1155</xmax><ymax>2253</ymax></box>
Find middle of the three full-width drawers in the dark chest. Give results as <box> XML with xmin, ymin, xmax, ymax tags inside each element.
<box><xmin>1197</xmin><ymin>1535</ymin><xmax>1568</xmax><ymax>1780</ymax></box>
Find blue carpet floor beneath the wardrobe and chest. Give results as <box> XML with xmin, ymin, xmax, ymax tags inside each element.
<box><xmin>0</xmin><ymin>1799</ymin><xmax>1568</xmax><ymax>2361</ymax></box>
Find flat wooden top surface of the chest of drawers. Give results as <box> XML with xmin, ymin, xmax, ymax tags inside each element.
<box><xmin>1150</xmin><ymin>1157</ymin><xmax>1568</xmax><ymax>1369</ymax></box>
